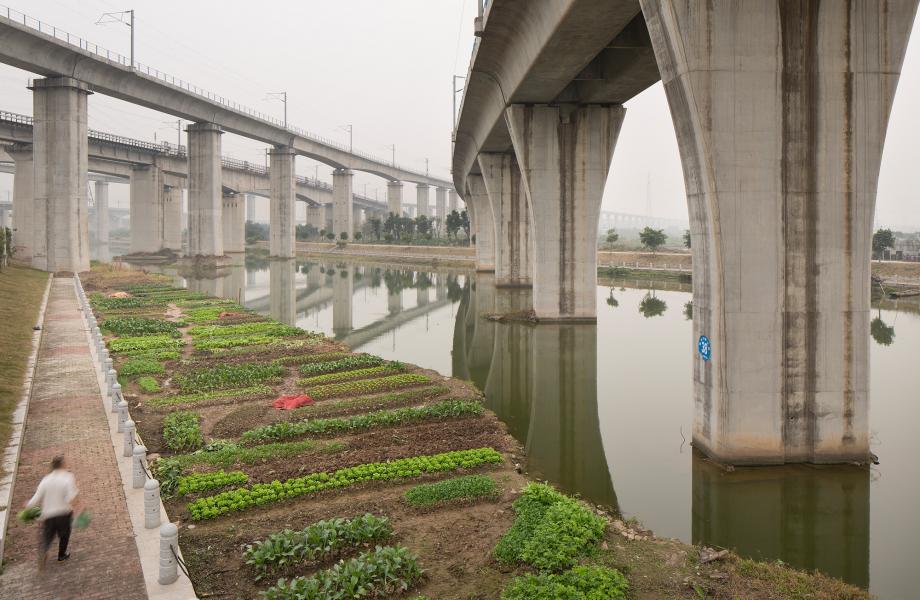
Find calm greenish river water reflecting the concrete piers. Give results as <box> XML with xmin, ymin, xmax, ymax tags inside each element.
<box><xmin>169</xmin><ymin>257</ymin><xmax>920</xmax><ymax>600</ymax></box>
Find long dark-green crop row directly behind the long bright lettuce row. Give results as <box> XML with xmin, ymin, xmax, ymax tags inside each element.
<box><xmin>242</xmin><ymin>399</ymin><xmax>483</xmax><ymax>441</ymax></box>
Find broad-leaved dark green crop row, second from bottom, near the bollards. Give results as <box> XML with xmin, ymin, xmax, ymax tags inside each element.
<box><xmin>243</xmin><ymin>513</ymin><xmax>393</xmax><ymax>580</ymax></box>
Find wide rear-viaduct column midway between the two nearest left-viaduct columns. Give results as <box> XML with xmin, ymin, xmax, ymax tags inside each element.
<box><xmin>129</xmin><ymin>164</ymin><xmax>165</xmax><ymax>254</ymax></box>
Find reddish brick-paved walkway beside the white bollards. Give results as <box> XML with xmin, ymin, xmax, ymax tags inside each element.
<box><xmin>0</xmin><ymin>277</ymin><xmax>147</xmax><ymax>600</ymax></box>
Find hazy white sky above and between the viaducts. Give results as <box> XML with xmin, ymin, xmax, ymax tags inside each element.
<box><xmin>0</xmin><ymin>0</ymin><xmax>920</xmax><ymax>229</ymax></box>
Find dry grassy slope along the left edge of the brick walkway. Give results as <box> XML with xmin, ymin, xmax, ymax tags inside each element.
<box><xmin>0</xmin><ymin>267</ymin><xmax>48</xmax><ymax>474</ymax></box>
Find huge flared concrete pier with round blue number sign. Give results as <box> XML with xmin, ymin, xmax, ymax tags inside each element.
<box><xmin>642</xmin><ymin>0</ymin><xmax>917</xmax><ymax>463</ymax></box>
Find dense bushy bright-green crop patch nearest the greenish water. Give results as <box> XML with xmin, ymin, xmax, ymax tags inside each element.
<box><xmin>494</xmin><ymin>483</ymin><xmax>607</xmax><ymax>571</ymax></box>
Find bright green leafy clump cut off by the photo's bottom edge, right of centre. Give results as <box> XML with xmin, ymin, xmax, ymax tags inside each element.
<box><xmin>502</xmin><ymin>566</ymin><xmax>629</xmax><ymax>600</ymax></box>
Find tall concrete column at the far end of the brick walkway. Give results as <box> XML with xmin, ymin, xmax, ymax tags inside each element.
<box><xmin>30</xmin><ymin>77</ymin><xmax>91</xmax><ymax>272</ymax></box>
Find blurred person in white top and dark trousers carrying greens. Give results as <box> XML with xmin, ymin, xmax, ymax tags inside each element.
<box><xmin>26</xmin><ymin>456</ymin><xmax>79</xmax><ymax>571</ymax></box>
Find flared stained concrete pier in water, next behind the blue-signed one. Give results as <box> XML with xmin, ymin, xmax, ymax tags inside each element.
<box><xmin>505</xmin><ymin>105</ymin><xmax>626</xmax><ymax>320</ymax></box>
